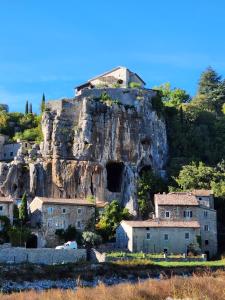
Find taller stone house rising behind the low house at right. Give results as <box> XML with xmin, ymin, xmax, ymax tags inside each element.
<box><xmin>155</xmin><ymin>191</ymin><xmax>217</xmax><ymax>257</ymax></box>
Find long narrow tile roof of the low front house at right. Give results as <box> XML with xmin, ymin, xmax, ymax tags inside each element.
<box><xmin>121</xmin><ymin>219</ymin><xmax>200</xmax><ymax>228</ymax></box>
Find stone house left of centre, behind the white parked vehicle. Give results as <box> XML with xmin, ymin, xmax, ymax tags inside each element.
<box><xmin>30</xmin><ymin>197</ymin><xmax>95</xmax><ymax>247</ymax></box>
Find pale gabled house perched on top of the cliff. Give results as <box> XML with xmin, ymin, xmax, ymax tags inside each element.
<box><xmin>75</xmin><ymin>67</ymin><xmax>145</xmax><ymax>96</ymax></box>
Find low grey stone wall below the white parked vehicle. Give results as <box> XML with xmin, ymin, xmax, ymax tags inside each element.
<box><xmin>0</xmin><ymin>247</ymin><xmax>87</xmax><ymax>265</ymax></box>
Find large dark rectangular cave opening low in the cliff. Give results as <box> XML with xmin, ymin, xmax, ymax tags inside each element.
<box><xmin>106</xmin><ymin>162</ymin><xmax>124</xmax><ymax>193</ymax></box>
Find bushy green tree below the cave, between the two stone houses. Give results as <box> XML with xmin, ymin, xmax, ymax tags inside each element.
<box><xmin>96</xmin><ymin>200</ymin><xmax>131</xmax><ymax>240</ymax></box>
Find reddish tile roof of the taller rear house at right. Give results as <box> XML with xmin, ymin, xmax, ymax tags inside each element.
<box><xmin>155</xmin><ymin>193</ymin><xmax>199</xmax><ymax>206</ymax></box>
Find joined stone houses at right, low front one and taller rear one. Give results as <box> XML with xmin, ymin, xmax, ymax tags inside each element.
<box><xmin>116</xmin><ymin>190</ymin><xmax>217</xmax><ymax>257</ymax></box>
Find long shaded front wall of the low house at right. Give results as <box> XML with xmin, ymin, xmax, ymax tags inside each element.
<box><xmin>132</xmin><ymin>228</ymin><xmax>199</xmax><ymax>253</ymax></box>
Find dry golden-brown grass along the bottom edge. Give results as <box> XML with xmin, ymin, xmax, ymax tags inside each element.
<box><xmin>1</xmin><ymin>272</ymin><xmax>225</xmax><ymax>300</ymax></box>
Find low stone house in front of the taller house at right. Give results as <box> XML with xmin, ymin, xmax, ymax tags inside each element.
<box><xmin>116</xmin><ymin>219</ymin><xmax>200</xmax><ymax>253</ymax></box>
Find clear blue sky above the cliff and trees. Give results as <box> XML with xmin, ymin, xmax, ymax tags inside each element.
<box><xmin>0</xmin><ymin>0</ymin><xmax>225</xmax><ymax>112</ymax></box>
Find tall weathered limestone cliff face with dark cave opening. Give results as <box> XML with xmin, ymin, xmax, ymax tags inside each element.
<box><xmin>0</xmin><ymin>88</ymin><xmax>167</xmax><ymax>213</ymax></box>
